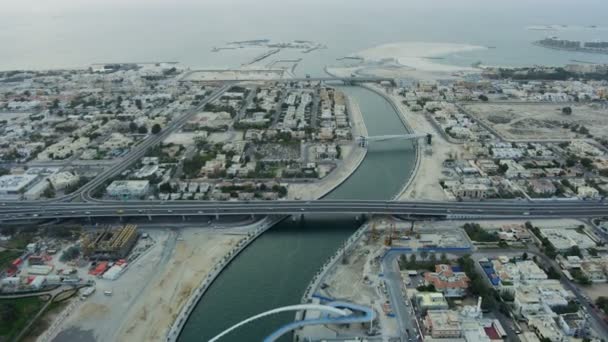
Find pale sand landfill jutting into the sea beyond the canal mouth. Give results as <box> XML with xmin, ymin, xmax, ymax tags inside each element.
<box><xmin>353</xmin><ymin>42</ymin><xmax>485</xmax><ymax>72</ymax></box>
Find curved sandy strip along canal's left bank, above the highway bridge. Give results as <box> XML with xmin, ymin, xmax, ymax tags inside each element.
<box><xmin>288</xmin><ymin>91</ymin><xmax>367</xmax><ymax>200</ymax></box>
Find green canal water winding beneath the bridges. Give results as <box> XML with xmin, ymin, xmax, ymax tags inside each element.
<box><xmin>179</xmin><ymin>87</ymin><xmax>415</xmax><ymax>342</ymax></box>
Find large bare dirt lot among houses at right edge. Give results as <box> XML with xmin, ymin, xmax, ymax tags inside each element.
<box><xmin>464</xmin><ymin>103</ymin><xmax>608</xmax><ymax>140</ymax></box>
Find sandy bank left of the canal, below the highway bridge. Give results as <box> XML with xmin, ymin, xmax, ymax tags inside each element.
<box><xmin>48</xmin><ymin>228</ymin><xmax>250</xmax><ymax>341</ymax></box>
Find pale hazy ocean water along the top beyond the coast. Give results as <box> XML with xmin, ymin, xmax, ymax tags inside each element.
<box><xmin>0</xmin><ymin>0</ymin><xmax>608</xmax><ymax>74</ymax></box>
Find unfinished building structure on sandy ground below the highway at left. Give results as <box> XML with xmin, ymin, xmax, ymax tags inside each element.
<box><xmin>82</xmin><ymin>224</ymin><xmax>138</xmax><ymax>260</ymax></box>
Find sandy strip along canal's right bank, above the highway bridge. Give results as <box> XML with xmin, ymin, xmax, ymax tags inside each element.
<box><xmin>371</xmin><ymin>86</ymin><xmax>464</xmax><ymax>201</ymax></box>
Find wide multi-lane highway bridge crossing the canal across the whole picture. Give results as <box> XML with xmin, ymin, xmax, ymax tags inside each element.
<box><xmin>0</xmin><ymin>200</ymin><xmax>608</xmax><ymax>222</ymax></box>
